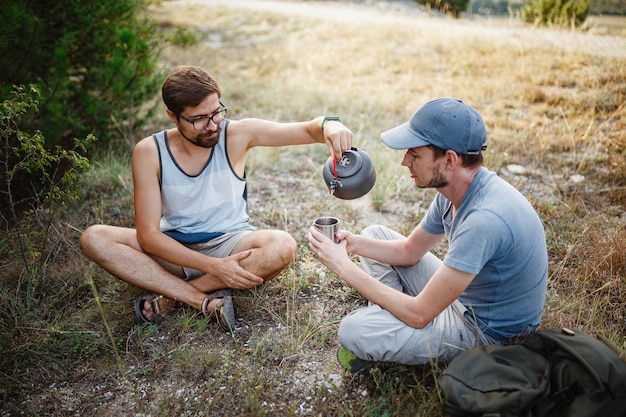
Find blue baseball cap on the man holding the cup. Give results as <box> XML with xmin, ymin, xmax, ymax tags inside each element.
<box><xmin>381</xmin><ymin>97</ymin><xmax>487</xmax><ymax>155</ymax></box>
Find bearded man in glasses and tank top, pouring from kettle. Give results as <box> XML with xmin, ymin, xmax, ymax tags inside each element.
<box><xmin>80</xmin><ymin>66</ymin><xmax>352</xmax><ymax>331</ymax></box>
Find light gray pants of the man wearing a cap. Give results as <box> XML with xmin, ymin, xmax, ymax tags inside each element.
<box><xmin>339</xmin><ymin>226</ymin><xmax>495</xmax><ymax>365</ymax></box>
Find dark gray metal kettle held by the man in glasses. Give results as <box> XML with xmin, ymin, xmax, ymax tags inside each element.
<box><xmin>323</xmin><ymin>148</ymin><xmax>376</xmax><ymax>200</ymax></box>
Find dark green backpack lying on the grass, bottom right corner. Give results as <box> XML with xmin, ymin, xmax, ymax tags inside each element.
<box><xmin>437</xmin><ymin>329</ymin><xmax>626</xmax><ymax>417</ymax></box>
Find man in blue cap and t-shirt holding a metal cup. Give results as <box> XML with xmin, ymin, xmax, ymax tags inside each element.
<box><xmin>309</xmin><ymin>98</ymin><xmax>548</xmax><ymax>372</ymax></box>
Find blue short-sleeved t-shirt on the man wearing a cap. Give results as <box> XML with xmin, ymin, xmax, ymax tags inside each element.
<box><xmin>420</xmin><ymin>167</ymin><xmax>548</xmax><ymax>341</ymax></box>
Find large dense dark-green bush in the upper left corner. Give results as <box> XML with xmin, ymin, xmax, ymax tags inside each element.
<box><xmin>0</xmin><ymin>0</ymin><xmax>195</xmax><ymax>147</ymax></box>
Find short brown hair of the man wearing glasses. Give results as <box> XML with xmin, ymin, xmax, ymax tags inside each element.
<box><xmin>161</xmin><ymin>66</ymin><xmax>222</xmax><ymax>115</ymax></box>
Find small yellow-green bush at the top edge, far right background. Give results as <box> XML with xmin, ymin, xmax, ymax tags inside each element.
<box><xmin>521</xmin><ymin>0</ymin><xmax>590</xmax><ymax>28</ymax></box>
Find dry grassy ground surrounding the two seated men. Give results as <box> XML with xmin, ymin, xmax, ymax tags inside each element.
<box><xmin>0</xmin><ymin>2</ymin><xmax>626</xmax><ymax>417</ymax></box>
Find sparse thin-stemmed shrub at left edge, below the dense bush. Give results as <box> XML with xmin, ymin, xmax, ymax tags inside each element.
<box><xmin>0</xmin><ymin>86</ymin><xmax>95</xmax><ymax>386</ymax></box>
